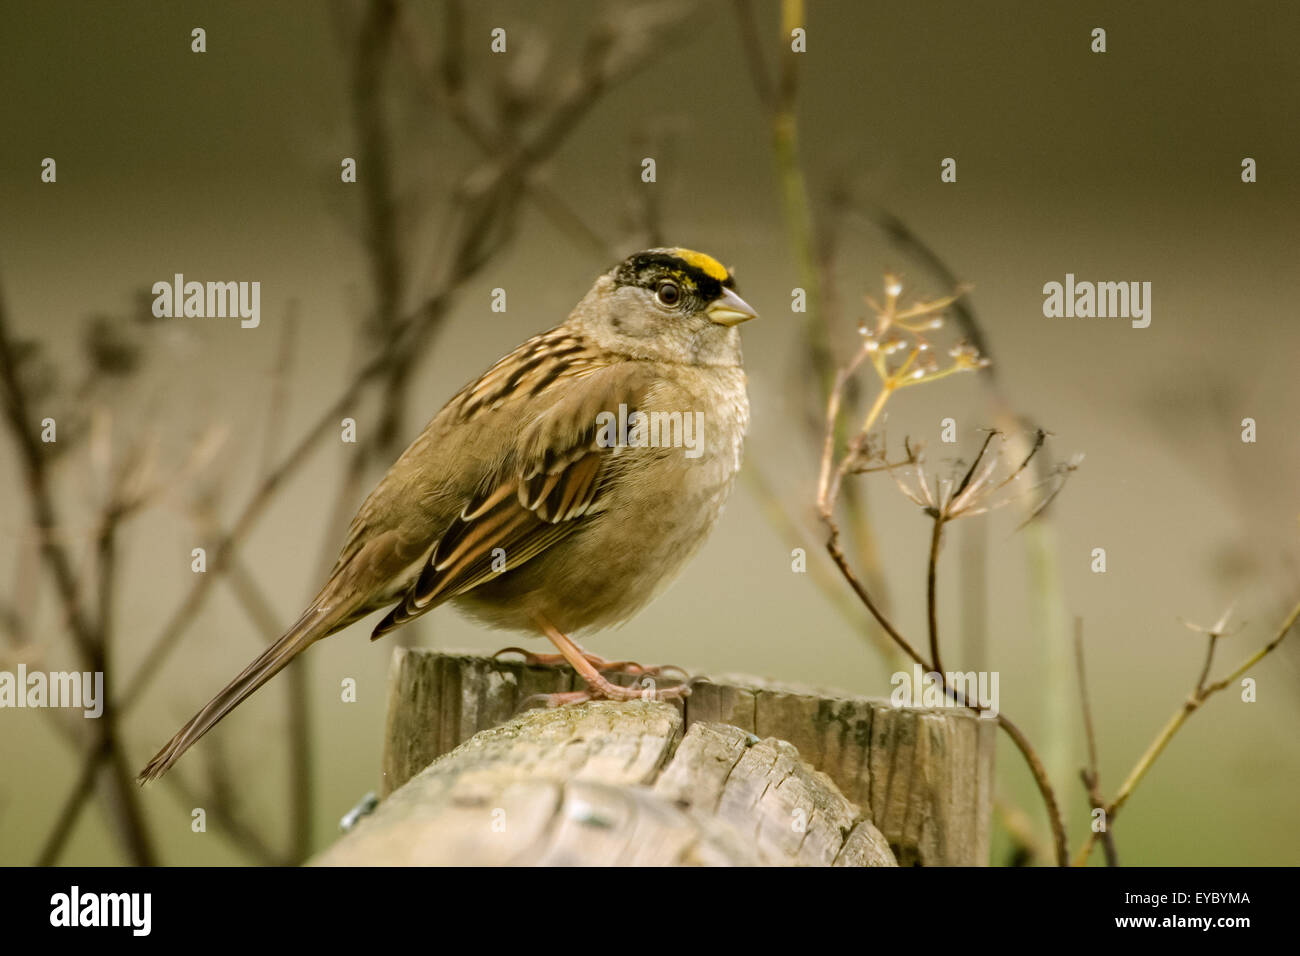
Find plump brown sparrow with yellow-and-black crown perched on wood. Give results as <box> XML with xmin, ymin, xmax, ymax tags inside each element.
<box><xmin>138</xmin><ymin>247</ymin><xmax>758</xmax><ymax>784</ymax></box>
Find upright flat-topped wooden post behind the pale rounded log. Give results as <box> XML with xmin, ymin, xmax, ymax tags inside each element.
<box><xmin>371</xmin><ymin>649</ymin><xmax>995</xmax><ymax>865</ymax></box>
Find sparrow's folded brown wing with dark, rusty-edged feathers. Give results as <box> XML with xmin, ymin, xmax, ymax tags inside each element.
<box><xmin>372</xmin><ymin>352</ymin><xmax>653</xmax><ymax>639</ymax></box>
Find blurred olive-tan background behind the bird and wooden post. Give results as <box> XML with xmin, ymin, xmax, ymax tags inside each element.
<box><xmin>0</xmin><ymin>0</ymin><xmax>1300</xmax><ymax>865</ymax></box>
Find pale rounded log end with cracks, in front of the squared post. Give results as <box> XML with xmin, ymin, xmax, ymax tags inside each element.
<box><xmin>313</xmin><ymin>701</ymin><xmax>894</xmax><ymax>866</ymax></box>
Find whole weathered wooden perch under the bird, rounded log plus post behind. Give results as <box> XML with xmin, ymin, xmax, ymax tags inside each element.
<box><xmin>340</xmin><ymin>649</ymin><xmax>993</xmax><ymax>865</ymax></box>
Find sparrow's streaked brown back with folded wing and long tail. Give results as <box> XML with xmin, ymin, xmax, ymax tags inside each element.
<box><xmin>139</xmin><ymin>329</ymin><xmax>624</xmax><ymax>782</ymax></box>
